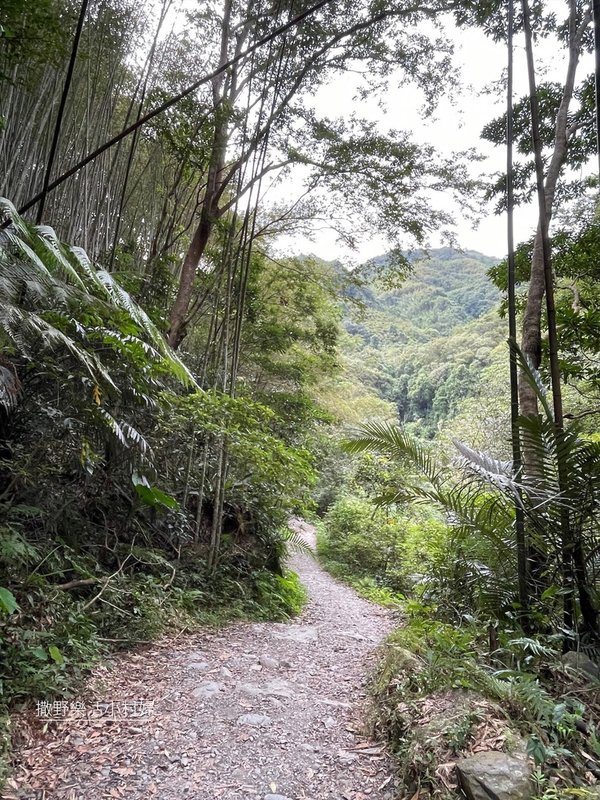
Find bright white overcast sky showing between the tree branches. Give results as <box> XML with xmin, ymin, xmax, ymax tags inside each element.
<box><xmin>278</xmin><ymin>12</ymin><xmax>591</xmax><ymax>260</ymax></box>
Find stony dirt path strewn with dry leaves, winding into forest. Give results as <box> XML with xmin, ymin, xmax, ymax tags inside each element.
<box><xmin>7</xmin><ymin>520</ymin><xmax>395</xmax><ymax>800</ymax></box>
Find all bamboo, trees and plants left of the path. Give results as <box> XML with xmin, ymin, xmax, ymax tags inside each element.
<box><xmin>0</xmin><ymin>0</ymin><xmax>474</xmax><ymax>784</ymax></box>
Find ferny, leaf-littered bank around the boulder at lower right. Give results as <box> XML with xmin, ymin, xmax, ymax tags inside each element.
<box><xmin>372</xmin><ymin>600</ymin><xmax>600</xmax><ymax>798</ymax></box>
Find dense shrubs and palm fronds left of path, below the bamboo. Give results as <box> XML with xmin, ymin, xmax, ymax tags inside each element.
<box><xmin>0</xmin><ymin>201</ymin><xmax>318</xmax><ymax>784</ymax></box>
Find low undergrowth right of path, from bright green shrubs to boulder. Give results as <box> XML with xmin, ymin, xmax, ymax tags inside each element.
<box><xmin>318</xmin><ymin>478</ymin><xmax>600</xmax><ymax>798</ymax></box>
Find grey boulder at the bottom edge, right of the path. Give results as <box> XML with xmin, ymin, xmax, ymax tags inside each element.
<box><xmin>456</xmin><ymin>751</ymin><xmax>533</xmax><ymax>800</ymax></box>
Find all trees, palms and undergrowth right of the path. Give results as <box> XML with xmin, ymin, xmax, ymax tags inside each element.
<box><xmin>320</xmin><ymin>0</ymin><xmax>600</xmax><ymax>798</ymax></box>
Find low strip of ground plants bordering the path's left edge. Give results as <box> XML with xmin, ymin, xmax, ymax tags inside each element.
<box><xmin>0</xmin><ymin>552</ymin><xmax>306</xmax><ymax>779</ymax></box>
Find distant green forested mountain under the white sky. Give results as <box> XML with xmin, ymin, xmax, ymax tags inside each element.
<box><xmin>343</xmin><ymin>248</ymin><xmax>507</xmax><ymax>436</ymax></box>
